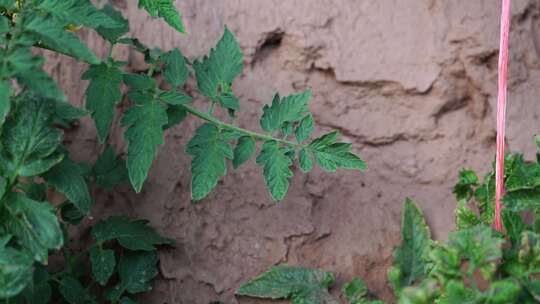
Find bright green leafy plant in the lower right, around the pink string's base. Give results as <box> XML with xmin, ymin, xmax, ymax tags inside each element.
<box><xmin>237</xmin><ymin>137</ymin><xmax>540</xmax><ymax>304</ymax></box>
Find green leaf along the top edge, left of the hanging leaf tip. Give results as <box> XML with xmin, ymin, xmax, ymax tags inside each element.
<box><xmin>36</xmin><ymin>0</ymin><xmax>123</xmax><ymax>29</ymax></box>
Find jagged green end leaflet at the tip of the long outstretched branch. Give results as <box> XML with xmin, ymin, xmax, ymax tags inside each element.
<box><xmin>307</xmin><ymin>131</ymin><xmax>367</xmax><ymax>172</ymax></box>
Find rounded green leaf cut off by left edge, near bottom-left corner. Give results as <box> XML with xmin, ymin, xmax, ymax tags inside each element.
<box><xmin>0</xmin><ymin>246</ymin><xmax>33</xmax><ymax>299</ymax></box>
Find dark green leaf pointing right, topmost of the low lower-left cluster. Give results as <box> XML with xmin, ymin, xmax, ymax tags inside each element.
<box><xmin>92</xmin><ymin>216</ymin><xmax>173</xmax><ymax>251</ymax></box>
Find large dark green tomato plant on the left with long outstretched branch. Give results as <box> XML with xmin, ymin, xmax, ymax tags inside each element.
<box><xmin>0</xmin><ymin>0</ymin><xmax>366</xmax><ymax>304</ymax></box>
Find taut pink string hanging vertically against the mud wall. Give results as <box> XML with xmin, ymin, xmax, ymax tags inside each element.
<box><xmin>495</xmin><ymin>0</ymin><xmax>510</xmax><ymax>232</ymax></box>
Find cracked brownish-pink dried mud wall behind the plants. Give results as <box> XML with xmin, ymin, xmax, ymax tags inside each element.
<box><xmin>48</xmin><ymin>0</ymin><xmax>540</xmax><ymax>304</ymax></box>
